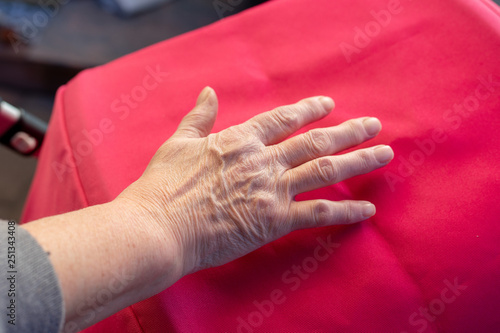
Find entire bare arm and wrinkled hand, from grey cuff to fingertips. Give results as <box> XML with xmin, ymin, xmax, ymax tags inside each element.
<box><xmin>23</xmin><ymin>88</ymin><xmax>393</xmax><ymax>332</ymax></box>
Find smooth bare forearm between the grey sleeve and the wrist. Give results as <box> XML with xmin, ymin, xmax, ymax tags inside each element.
<box><xmin>23</xmin><ymin>200</ymin><xmax>180</xmax><ymax>330</ymax></box>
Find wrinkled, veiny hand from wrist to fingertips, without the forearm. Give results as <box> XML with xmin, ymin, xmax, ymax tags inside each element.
<box><xmin>117</xmin><ymin>87</ymin><xmax>393</xmax><ymax>278</ymax></box>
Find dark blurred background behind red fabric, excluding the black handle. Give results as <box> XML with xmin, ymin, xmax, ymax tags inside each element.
<box><xmin>0</xmin><ymin>0</ymin><xmax>265</xmax><ymax>220</ymax></box>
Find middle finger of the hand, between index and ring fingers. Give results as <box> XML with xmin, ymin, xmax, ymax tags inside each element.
<box><xmin>269</xmin><ymin>117</ymin><xmax>382</xmax><ymax>168</ymax></box>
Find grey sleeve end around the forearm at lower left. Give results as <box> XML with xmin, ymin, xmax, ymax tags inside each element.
<box><xmin>0</xmin><ymin>220</ymin><xmax>64</xmax><ymax>333</ymax></box>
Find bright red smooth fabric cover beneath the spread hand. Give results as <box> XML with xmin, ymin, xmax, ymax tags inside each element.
<box><xmin>24</xmin><ymin>0</ymin><xmax>500</xmax><ymax>332</ymax></box>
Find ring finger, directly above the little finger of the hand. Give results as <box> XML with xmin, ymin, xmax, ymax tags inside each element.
<box><xmin>284</xmin><ymin>145</ymin><xmax>394</xmax><ymax>195</ymax></box>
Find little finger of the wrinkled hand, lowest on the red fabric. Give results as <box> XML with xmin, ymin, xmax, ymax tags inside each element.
<box><xmin>289</xmin><ymin>199</ymin><xmax>375</xmax><ymax>231</ymax></box>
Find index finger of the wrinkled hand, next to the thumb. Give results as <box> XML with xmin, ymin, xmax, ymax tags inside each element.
<box><xmin>243</xmin><ymin>96</ymin><xmax>335</xmax><ymax>145</ymax></box>
